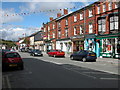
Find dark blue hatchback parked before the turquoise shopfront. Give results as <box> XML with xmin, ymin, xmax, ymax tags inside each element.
<box><xmin>70</xmin><ymin>50</ymin><xmax>97</xmax><ymax>62</ymax></box>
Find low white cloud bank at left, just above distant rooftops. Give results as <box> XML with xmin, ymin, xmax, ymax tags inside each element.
<box><xmin>0</xmin><ymin>28</ymin><xmax>38</xmax><ymax>41</ymax></box>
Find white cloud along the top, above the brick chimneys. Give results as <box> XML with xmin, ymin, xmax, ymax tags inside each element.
<box><xmin>20</xmin><ymin>0</ymin><xmax>75</xmax><ymax>17</ymax></box>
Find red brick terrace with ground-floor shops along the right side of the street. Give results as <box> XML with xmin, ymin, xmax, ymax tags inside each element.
<box><xmin>43</xmin><ymin>2</ymin><xmax>120</xmax><ymax>58</ymax></box>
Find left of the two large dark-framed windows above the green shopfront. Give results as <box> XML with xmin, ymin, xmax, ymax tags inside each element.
<box><xmin>98</xmin><ymin>18</ymin><xmax>106</xmax><ymax>32</ymax></box>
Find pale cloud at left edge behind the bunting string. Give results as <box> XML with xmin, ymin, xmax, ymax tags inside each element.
<box><xmin>0</xmin><ymin>9</ymin><xmax>23</xmax><ymax>24</ymax></box>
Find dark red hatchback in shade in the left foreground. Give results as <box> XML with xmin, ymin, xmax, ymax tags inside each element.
<box><xmin>2</xmin><ymin>51</ymin><xmax>24</xmax><ymax>70</ymax></box>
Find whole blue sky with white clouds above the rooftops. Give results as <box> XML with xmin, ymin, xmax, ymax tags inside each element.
<box><xmin>0</xmin><ymin>0</ymin><xmax>97</xmax><ymax>41</ymax></box>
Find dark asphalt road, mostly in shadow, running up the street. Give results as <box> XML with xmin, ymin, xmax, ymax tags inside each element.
<box><xmin>3</xmin><ymin>53</ymin><xmax>118</xmax><ymax>88</ymax></box>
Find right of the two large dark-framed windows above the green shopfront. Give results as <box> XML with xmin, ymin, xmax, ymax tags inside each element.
<box><xmin>110</xmin><ymin>16</ymin><xmax>118</xmax><ymax>30</ymax></box>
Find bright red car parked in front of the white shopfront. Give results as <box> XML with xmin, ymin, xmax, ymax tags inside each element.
<box><xmin>47</xmin><ymin>50</ymin><xmax>65</xmax><ymax>57</ymax></box>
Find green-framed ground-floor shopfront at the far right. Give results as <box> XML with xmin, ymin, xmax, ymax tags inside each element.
<box><xmin>96</xmin><ymin>33</ymin><xmax>120</xmax><ymax>58</ymax></box>
